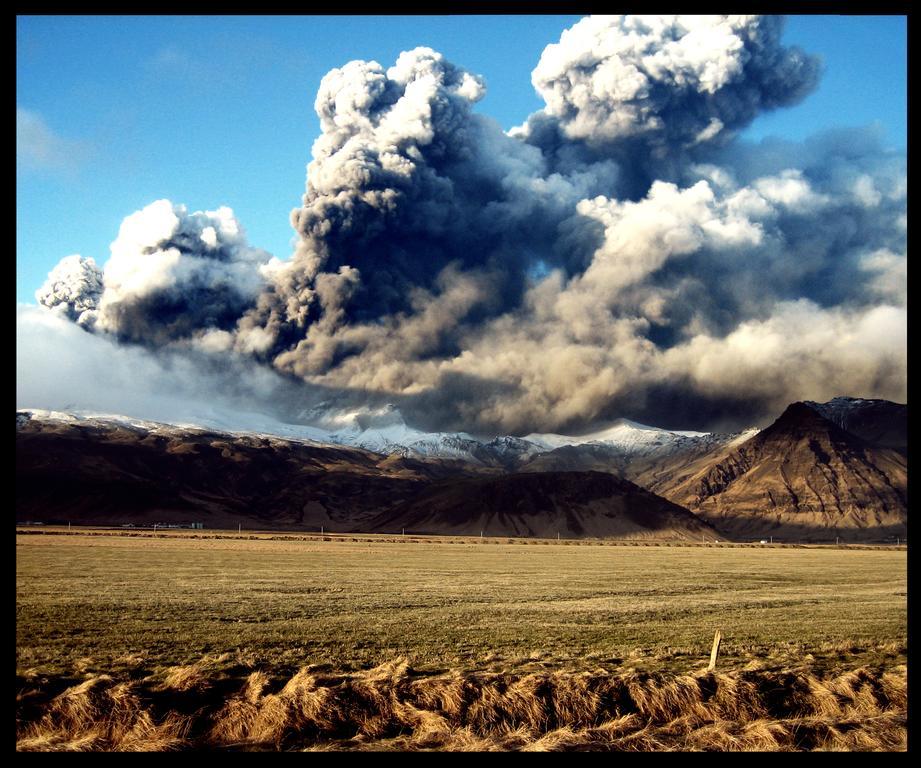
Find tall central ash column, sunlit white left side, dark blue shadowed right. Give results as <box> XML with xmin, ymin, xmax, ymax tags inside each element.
<box><xmin>239</xmin><ymin>48</ymin><xmax>616</xmax><ymax>375</ymax></box>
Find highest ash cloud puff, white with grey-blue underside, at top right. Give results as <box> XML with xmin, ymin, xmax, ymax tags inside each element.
<box><xmin>518</xmin><ymin>16</ymin><xmax>819</xmax><ymax>197</ymax></box>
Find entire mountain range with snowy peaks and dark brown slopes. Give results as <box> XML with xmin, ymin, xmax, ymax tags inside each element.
<box><xmin>16</xmin><ymin>398</ymin><xmax>907</xmax><ymax>541</ymax></box>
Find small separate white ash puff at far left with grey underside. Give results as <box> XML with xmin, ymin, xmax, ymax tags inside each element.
<box><xmin>36</xmin><ymin>200</ymin><xmax>269</xmax><ymax>347</ymax></box>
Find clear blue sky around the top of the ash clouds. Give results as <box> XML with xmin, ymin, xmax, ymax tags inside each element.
<box><xmin>16</xmin><ymin>15</ymin><xmax>907</xmax><ymax>303</ymax></box>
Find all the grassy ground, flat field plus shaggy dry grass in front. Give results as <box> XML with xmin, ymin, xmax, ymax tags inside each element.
<box><xmin>17</xmin><ymin>533</ymin><xmax>907</xmax><ymax>750</ymax></box>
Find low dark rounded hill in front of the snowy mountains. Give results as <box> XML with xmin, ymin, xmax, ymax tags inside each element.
<box><xmin>370</xmin><ymin>472</ymin><xmax>719</xmax><ymax>541</ymax></box>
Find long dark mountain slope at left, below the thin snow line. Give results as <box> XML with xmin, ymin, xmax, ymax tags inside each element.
<box><xmin>16</xmin><ymin>422</ymin><xmax>439</xmax><ymax>529</ymax></box>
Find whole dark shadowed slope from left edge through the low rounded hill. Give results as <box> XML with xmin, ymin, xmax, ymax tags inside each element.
<box><xmin>16</xmin><ymin>414</ymin><xmax>716</xmax><ymax>539</ymax></box>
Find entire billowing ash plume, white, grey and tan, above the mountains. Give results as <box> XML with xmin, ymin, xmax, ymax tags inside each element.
<box><xmin>30</xmin><ymin>17</ymin><xmax>907</xmax><ymax>434</ymax></box>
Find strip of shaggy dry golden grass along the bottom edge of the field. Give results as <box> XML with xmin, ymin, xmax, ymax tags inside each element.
<box><xmin>17</xmin><ymin>659</ymin><xmax>907</xmax><ymax>751</ymax></box>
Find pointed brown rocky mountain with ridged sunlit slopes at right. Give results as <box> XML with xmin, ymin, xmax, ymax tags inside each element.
<box><xmin>657</xmin><ymin>403</ymin><xmax>908</xmax><ymax>540</ymax></box>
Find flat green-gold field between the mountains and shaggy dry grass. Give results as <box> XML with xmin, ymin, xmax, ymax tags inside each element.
<box><xmin>16</xmin><ymin>533</ymin><xmax>907</xmax><ymax>749</ymax></box>
